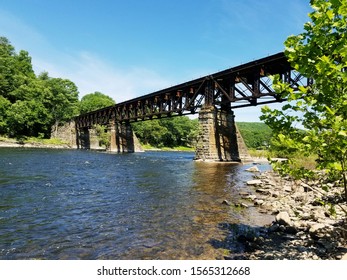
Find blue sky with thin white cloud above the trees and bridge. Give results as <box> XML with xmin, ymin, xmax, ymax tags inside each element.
<box><xmin>0</xmin><ymin>0</ymin><xmax>311</xmax><ymax>121</ymax></box>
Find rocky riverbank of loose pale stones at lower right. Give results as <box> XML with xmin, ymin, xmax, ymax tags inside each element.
<box><xmin>222</xmin><ymin>168</ymin><xmax>347</xmax><ymax>260</ymax></box>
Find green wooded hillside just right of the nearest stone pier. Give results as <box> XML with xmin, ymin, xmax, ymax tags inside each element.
<box><xmin>236</xmin><ymin>122</ymin><xmax>272</xmax><ymax>149</ymax></box>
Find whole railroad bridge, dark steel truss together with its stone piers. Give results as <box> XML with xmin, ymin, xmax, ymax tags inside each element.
<box><xmin>64</xmin><ymin>52</ymin><xmax>312</xmax><ymax>161</ymax></box>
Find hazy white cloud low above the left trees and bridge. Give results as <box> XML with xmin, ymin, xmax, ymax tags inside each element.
<box><xmin>33</xmin><ymin>52</ymin><xmax>174</xmax><ymax>103</ymax></box>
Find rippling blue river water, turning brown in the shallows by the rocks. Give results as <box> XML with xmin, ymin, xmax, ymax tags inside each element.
<box><xmin>0</xmin><ymin>148</ymin><xmax>274</xmax><ymax>260</ymax></box>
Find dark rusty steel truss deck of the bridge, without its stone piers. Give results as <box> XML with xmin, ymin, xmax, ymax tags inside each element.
<box><xmin>75</xmin><ymin>52</ymin><xmax>312</xmax><ymax>129</ymax></box>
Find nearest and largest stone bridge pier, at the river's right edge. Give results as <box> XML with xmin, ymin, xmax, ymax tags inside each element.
<box><xmin>195</xmin><ymin>106</ymin><xmax>247</xmax><ymax>162</ymax></box>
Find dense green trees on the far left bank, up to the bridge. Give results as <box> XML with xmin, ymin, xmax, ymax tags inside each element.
<box><xmin>0</xmin><ymin>37</ymin><xmax>114</xmax><ymax>138</ymax></box>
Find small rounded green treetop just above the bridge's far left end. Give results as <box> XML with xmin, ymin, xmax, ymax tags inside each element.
<box><xmin>80</xmin><ymin>91</ymin><xmax>116</xmax><ymax>114</ymax></box>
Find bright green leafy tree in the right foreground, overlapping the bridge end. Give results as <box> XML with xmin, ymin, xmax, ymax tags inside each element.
<box><xmin>262</xmin><ymin>0</ymin><xmax>347</xmax><ymax>201</ymax></box>
